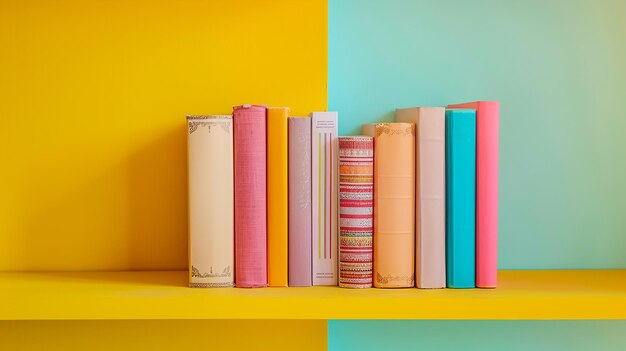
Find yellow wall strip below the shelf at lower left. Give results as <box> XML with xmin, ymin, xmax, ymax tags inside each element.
<box><xmin>0</xmin><ymin>320</ymin><xmax>327</xmax><ymax>351</ymax></box>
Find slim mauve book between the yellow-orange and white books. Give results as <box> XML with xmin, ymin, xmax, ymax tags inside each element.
<box><xmin>289</xmin><ymin>117</ymin><xmax>313</xmax><ymax>286</ymax></box>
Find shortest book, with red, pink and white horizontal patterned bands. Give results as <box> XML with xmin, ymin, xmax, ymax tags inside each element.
<box><xmin>339</xmin><ymin>136</ymin><xmax>374</xmax><ymax>288</ymax></box>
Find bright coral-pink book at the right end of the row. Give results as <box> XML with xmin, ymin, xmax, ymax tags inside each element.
<box><xmin>448</xmin><ymin>101</ymin><xmax>500</xmax><ymax>288</ymax></box>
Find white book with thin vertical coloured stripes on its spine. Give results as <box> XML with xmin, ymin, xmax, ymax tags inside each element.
<box><xmin>311</xmin><ymin>112</ymin><xmax>338</xmax><ymax>285</ymax></box>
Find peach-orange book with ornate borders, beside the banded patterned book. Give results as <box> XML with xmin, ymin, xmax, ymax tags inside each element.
<box><xmin>363</xmin><ymin>123</ymin><xmax>415</xmax><ymax>288</ymax></box>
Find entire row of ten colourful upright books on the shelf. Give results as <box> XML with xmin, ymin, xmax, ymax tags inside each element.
<box><xmin>187</xmin><ymin>101</ymin><xmax>499</xmax><ymax>288</ymax></box>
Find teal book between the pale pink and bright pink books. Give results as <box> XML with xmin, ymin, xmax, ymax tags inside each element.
<box><xmin>446</xmin><ymin>109</ymin><xmax>476</xmax><ymax>288</ymax></box>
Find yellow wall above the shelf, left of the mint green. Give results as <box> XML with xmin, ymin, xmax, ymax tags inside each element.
<box><xmin>0</xmin><ymin>0</ymin><xmax>327</xmax><ymax>271</ymax></box>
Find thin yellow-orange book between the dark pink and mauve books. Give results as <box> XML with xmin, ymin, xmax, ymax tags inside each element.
<box><xmin>267</xmin><ymin>107</ymin><xmax>289</xmax><ymax>286</ymax></box>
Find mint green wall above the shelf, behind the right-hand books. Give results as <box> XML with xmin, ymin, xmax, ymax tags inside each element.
<box><xmin>328</xmin><ymin>0</ymin><xmax>626</xmax><ymax>269</ymax></box>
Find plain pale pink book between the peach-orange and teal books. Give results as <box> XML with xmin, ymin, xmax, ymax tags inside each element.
<box><xmin>396</xmin><ymin>107</ymin><xmax>446</xmax><ymax>289</ymax></box>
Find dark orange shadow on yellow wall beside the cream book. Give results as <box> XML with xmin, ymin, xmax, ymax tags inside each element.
<box><xmin>127</xmin><ymin>124</ymin><xmax>188</xmax><ymax>270</ymax></box>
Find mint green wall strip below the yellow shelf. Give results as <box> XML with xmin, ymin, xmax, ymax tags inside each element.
<box><xmin>328</xmin><ymin>321</ymin><xmax>626</xmax><ymax>351</ymax></box>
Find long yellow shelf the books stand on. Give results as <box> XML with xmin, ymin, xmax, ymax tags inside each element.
<box><xmin>0</xmin><ymin>270</ymin><xmax>626</xmax><ymax>320</ymax></box>
